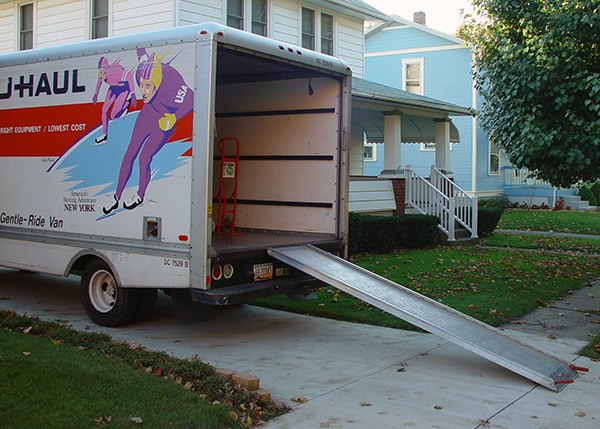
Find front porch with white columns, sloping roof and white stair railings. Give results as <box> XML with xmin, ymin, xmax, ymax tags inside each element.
<box><xmin>349</xmin><ymin>79</ymin><xmax>477</xmax><ymax>241</ymax></box>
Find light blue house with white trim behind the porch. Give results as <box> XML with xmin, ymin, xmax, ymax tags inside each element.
<box><xmin>363</xmin><ymin>12</ymin><xmax>585</xmax><ymax>208</ymax></box>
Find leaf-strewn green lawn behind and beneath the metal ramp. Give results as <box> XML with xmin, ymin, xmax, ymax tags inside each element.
<box><xmin>254</xmin><ymin>246</ymin><xmax>600</xmax><ymax>328</ymax></box>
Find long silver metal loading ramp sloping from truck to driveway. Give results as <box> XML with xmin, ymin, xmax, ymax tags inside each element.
<box><xmin>268</xmin><ymin>245</ymin><xmax>585</xmax><ymax>392</ymax></box>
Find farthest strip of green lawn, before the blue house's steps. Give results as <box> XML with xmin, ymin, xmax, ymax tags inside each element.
<box><xmin>498</xmin><ymin>209</ymin><xmax>600</xmax><ymax>235</ymax></box>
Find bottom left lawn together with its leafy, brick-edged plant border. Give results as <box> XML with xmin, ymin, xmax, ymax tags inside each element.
<box><xmin>0</xmin><ymin>311</ymin><xmax>287</xmax><ymax>428</ymax></box>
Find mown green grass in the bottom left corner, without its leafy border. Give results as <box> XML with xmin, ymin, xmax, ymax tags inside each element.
<box><xmin>0</xmin><ymin>330</ymin><xmax>236</xmax><ymax>429</ymax></box>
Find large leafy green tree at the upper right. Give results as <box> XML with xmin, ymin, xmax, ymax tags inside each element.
<box><xmin>458</xmin><ymin>0</ymin><xmax>600</xmax><ymax>186</ymax></box>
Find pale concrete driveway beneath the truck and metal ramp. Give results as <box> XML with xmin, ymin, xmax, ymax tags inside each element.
<box><xmin>0</xmin><ymin>269</ymin><xmax>600</xmax><ymax>429</ymax></box>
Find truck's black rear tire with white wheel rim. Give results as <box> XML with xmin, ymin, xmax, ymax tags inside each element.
<box><xmin>81</xmin><ymin>259</ymin><xmax>140</xmax><ymax>326</ymax></box>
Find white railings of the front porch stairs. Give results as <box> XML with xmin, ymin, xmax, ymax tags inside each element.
<box><xmin>404</xmin><ymin>166</ymin><xmax>477</xmax><ymax>241</ymax></box>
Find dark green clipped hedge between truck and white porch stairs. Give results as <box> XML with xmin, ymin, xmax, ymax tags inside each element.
<box><xmin>348</xmin><ymin>213</ymin><xmax>440</xmax><ymax>255</ymax></box>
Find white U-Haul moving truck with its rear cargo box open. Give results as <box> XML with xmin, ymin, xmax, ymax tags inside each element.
<box><xmin>0</xmin><ymin>23</ymin><xmax>350</xmax><ymax>326</ymax></box>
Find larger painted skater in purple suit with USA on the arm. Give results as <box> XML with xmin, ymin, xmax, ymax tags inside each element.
<box><xmin>103</xmin><ymin>49</ymin><xmax>194</xmax><ymax>214</ymax></box>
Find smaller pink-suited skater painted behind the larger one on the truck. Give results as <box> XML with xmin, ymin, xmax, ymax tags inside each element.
<box><xmin>92</xmin><ymin>57</ymin><xmax>136</xmax><ymax>144</ymax></box>
